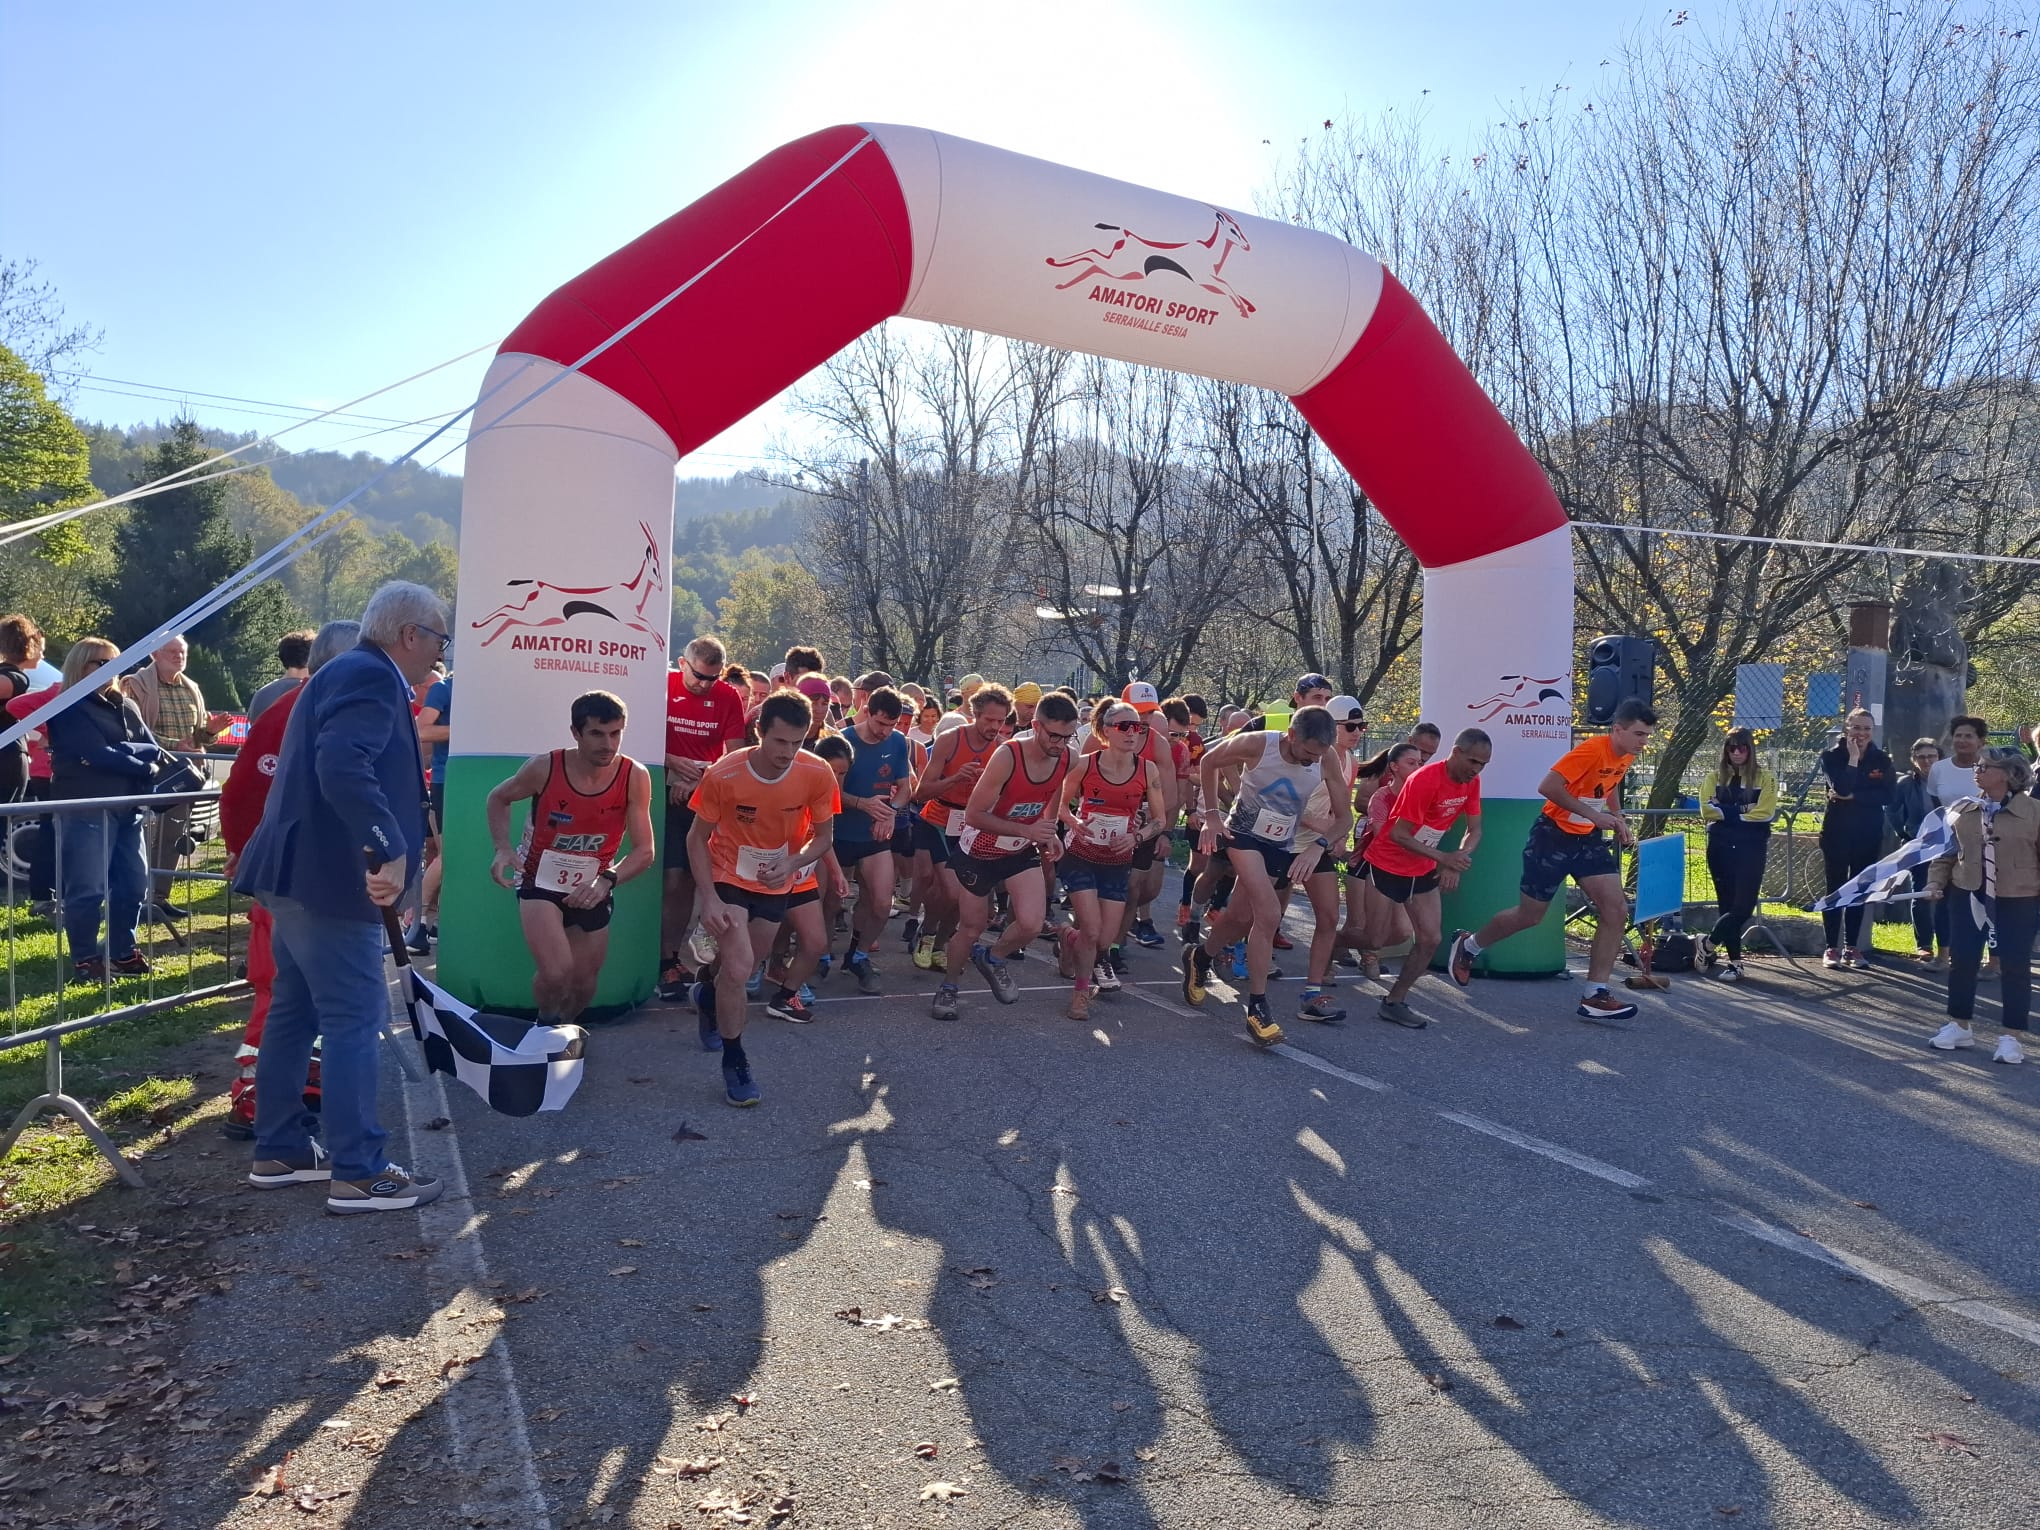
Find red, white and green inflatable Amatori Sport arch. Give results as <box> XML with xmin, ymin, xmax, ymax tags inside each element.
<box><xmin>441</xmin><ymin>126</ymin><xmax>1573</xmax><ymax>1008</ymax></box>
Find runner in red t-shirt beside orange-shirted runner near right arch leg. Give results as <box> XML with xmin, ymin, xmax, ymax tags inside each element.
<box><xmin>1367</xmin><ymin>728</ymin><xmax>1493</xmax><ymax>1030</ymax></box>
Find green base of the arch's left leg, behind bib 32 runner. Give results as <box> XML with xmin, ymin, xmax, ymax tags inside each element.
<box><xmin>439</xmin><ymin>755</ymin><xmax>665</xmax><ymax>1014</ymax></box>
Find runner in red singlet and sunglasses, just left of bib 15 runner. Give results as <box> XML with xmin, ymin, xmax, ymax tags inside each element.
<box><xmin>928</xmin><ymin>701</ymin><xmax>1077</xmax><ymax>1020</ymax></box>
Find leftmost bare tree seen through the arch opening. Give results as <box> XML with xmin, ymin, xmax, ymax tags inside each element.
<box><xmin>789</xmin><ymin>324</ymin><xmax>1040</xmax><ymax>677</ymax></box>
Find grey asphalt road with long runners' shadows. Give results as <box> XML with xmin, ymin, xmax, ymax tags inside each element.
<box><xmin>165</xmin><ymin>922</ymin><xmax>2040</xmax><ymax>1530</ymax></box>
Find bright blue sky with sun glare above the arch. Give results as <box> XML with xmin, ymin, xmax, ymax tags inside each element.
<box><xmin>0</xmin><ymin>0</ymin><xmax>1672</xmax><ymax>473</ymax></box>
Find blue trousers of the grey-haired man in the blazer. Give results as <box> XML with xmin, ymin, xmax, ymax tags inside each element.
<box><xmin>255</xmin><ymin>898</ymin><xmax>390</xmax><ymax>1179</ymax></box>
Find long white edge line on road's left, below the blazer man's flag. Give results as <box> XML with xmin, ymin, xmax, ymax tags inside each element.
<box><xmin>394</xmin><ymin>1012</ymin><xmax>553</xmax><ymax>1530</ymax></box>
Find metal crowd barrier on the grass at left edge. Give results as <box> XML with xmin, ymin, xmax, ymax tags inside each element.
<box><xmin>0</xmin><ymin>783</ymin><xmax>249</xmax><ymax>1185</ymax></box>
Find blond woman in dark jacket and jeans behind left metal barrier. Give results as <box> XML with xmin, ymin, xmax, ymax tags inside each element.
<box><xmin>49</xmin><ymin>636</ymin><xmax>171</xmax><ymax>983</ymax></box>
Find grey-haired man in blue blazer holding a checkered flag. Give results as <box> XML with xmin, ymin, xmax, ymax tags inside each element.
<box><xmin>235</xmin><ymin>581</ymin><xmax>451</xmax><ymax>1212</ymax></box>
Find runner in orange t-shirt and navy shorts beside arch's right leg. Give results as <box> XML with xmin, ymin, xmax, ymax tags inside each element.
<box><xmin>1446</xmin><ymin>698</ymin><xmax>1656</xmax><ymax>1020</ymax></box>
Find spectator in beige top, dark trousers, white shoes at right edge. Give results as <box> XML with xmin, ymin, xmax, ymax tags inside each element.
<box><xmin>1928</xmin><ymin>749</ymin><xmax>2040</xmax><ymax>1063</ymax></box>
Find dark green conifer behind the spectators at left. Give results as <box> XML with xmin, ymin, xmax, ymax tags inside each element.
<box><xmin>98</xmin><ymin>420</ymin><xmax>302</xmax><ymax>700</ymax></box>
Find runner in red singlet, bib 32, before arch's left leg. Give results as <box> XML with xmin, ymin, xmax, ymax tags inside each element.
<box><xmin>488</xmin><ymin>692</ymin><xmax>657</xmax><ymax>1024</ymax></box>
